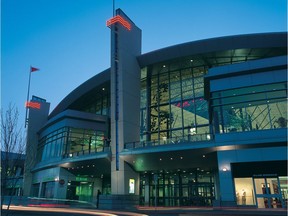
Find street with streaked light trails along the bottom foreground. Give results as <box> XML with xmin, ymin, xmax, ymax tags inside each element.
<box><xmin>2</xmin><ymin>206</ymin><xmax>287</xmax><ymax>216</ymax></box>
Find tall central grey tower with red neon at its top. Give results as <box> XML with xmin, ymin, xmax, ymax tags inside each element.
<box><xmin>107</xmin><ymin>9</ymin><xmax>141</xmax><ymax>207</ymax></box>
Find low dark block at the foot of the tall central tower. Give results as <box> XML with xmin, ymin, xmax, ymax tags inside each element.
<box><xmin>99</xmin><ymin>195</ymin><xmax>139</xmax><ymax>210</ymax></box>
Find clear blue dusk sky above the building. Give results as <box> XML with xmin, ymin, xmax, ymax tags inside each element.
<box><xmin>1</xmin><ymin>0</ymin><xmax>287</xmax><ymax>126</ymax></box>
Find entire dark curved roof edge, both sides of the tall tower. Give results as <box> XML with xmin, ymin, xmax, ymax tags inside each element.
<box><xmin>49</xmin><ymin>32</ymin><xmax>287</xmax><ymax>119</ymax></box>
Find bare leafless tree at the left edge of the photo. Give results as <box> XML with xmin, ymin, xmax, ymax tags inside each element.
<box><xmin>1</xmin><ymin>104</ymin><xmax>26</xmax><ymax>210</ymax></box>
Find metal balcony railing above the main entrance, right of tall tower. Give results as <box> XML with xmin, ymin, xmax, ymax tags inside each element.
<box><xmin>124</xmin><ymin>133</ymin><xmax>213</xmax><ymax>149</ymax></box>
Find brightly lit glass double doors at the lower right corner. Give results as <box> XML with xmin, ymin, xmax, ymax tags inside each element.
<box><xmin>254</xmin><ymin>177</ymin><xmax>284</xmax><ymax>208</ymax></box>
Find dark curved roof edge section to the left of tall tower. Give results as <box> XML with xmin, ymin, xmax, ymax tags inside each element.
<box><xmin>48</xmin><ymin>68</ymin><xmax>110</xmax><ymax>119</ymax></box>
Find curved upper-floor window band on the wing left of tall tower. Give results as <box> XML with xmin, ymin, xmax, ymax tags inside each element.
<box><xmin>37</xmin><ymin>127</ymin><xmax>106</xmax><ymax>162</ymax></box>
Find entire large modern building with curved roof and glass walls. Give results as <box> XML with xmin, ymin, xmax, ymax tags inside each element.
<box><xmin>24</xmin><ymin>9</ymin><xmax>288</xmax><ymax>208</ymax></box>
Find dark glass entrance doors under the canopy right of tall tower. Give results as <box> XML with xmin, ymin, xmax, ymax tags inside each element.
<box><xmin>140</xmin><ymin>170</ymin><xmax>215</xmax><ymax>206</ymax></box>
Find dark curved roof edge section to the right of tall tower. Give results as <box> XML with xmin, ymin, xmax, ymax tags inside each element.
<box><xmin>137</xmin><ymin>32</ymin><xmax>287</xmax><ymax>67</ymax></box>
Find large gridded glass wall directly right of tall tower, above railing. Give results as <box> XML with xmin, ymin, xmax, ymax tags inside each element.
<box><xmin>140</xmin><ymin>60</ymin><xmax>209</xmax><ymax>142</ymax></box>
